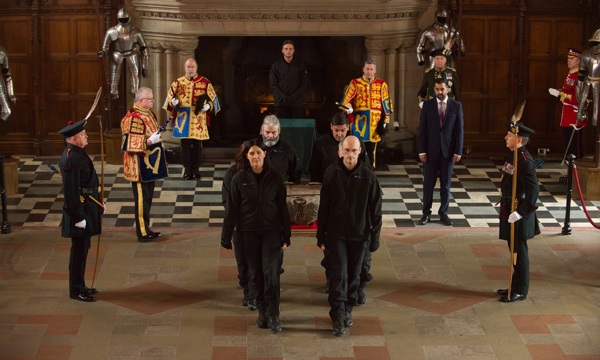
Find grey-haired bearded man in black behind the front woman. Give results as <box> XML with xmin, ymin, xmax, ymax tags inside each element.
<box><xmin>260</xmin><ymin>115</ymin><xmax>302</xmax><ymax>184</ymax></box>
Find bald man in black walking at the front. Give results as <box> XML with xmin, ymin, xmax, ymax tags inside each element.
<box><xmin>317</xmin><ymin>135</ymin><xmax>382</xmax><ymax>336</ymax></box>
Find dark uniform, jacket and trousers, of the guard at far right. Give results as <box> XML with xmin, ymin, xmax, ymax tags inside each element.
<box><xmin>500</xmin><ymin>146</ymin><xmax>540</xmax><ymax>295</ymax></box>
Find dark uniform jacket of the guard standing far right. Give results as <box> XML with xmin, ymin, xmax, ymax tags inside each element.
<box><xmin>500</xmin><ymin>146</ymin><xmax>540</xmax><ymax>240</ymax></box>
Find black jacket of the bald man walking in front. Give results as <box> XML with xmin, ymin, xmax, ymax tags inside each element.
<box><xmin>317</xmin><ymin>159</ymin><xmax>382</xmax><ymax>246</ymax></box>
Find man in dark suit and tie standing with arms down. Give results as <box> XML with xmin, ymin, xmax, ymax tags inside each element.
<box><xmin>419</xmin><ymin>79</ymin><xmax>463</xmax><ymax>226</ymax></box>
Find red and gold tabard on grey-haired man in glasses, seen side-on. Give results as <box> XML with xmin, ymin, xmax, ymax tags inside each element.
<box><xmin>121</xmin><ymin>104</ymin><xmax>163</xmax><ymax>181</ymax></box>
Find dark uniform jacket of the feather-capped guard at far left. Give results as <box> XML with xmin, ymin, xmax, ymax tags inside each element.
<box><xmin>58</xmin><ymin>144</ymin><xmax>103</xmax><ymax>237</ymax></box>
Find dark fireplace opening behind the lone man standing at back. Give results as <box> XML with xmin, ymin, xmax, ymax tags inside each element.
<box><xmin>195</xmin><ymin>36</ymin><xmax>366</xmax><ymax>147</ymax></box>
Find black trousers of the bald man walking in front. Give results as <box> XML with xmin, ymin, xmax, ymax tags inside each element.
<box><xmin>327</xmin><ymin>239</ymin><xmax>369</xmax><ymax>321</ymax></box>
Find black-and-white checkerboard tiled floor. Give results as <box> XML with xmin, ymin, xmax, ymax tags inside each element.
<box><xmin>7</xmin><ymin>156</ymin><xmax>600</xmax><ymax>228</ymax></box>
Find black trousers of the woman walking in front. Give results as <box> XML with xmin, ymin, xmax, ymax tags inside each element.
<box><xmin>238</xmin><ymin>230</ymin><xmax>283</xmax><ymax>316</ymax></box>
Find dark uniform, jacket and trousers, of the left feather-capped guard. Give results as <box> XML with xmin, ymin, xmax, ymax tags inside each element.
<box><xmin>58</xmin><ymin>144</ymin><xmax>103</xmax><ymax>297</ymax></box>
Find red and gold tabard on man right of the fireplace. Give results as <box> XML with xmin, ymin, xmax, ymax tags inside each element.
<box><xmin>342</xmin><ymin>76</ymin><xmax>393</xmax><ymax>142</ymax></box>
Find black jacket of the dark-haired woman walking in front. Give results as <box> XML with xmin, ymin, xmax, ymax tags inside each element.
<box><xmin>221</xmin><ymin>169</ymin><xmax>291</xmax><ymax>244</ymax></box>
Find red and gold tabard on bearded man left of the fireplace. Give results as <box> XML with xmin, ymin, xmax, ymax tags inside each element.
<box><xmin>163</xmin><ymin>74</ymin><xmax>221</xmax><ymax>140</ymax></box>
